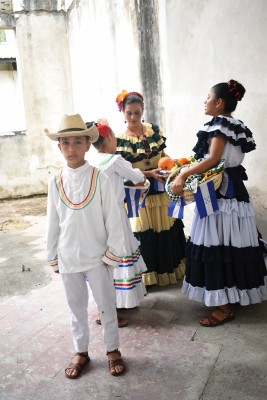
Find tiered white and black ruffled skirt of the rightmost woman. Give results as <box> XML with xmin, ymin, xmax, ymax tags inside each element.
<box><xmin>182</xmin><ymin>198</ymin><xmax>267</xmax><ymax>306</ymax></box>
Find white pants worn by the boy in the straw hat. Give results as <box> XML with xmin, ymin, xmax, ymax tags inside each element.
<box><xmin>61</xmin><ymin>264</ymin><xmax>119</xmax><ymax>353</ymax></box>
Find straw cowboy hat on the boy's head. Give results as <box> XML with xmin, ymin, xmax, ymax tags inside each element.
<box><xmin>44</xmin><ymin>114</ymin><xmax>99</xmax><ymax>143</ymax></box>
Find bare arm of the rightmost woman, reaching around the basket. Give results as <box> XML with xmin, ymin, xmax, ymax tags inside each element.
<box><xmin>171</xmin><ymin>136</ymin><xmax>226</xmax><ymax>196</ymax></box>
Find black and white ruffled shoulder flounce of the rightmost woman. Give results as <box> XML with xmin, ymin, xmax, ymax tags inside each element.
<box><xmin>193</xmin><ymin>116</ymin><xmax>256</xmax><ymax>159</ymax></box>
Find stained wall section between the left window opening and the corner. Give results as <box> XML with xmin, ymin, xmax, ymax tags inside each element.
<box><xmin>0</xmin><ymin>2</ymin><xmax>73</xmax><ymax>198</ymax></box>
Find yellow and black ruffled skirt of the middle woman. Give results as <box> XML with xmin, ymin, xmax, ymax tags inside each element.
<box><xmin>130</xmin><ymin>193</ymin><xmax>186</xmax><ymax>286</ymax></box>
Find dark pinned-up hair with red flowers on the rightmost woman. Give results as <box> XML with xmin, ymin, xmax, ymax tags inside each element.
<box><xmin>212</xmin><ymin>79</ymin><xmax>246</xmax><ymax>113</ymax></box>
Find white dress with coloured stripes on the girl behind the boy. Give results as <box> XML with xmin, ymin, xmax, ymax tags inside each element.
<box><xmin>96</xmin><ymin>153</ymin><xmax>147</xmax><ymax>308</ymax></box>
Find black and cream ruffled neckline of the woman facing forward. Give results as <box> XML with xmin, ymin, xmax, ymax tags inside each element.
<box><xmin>116</xmin><ymin>124</ymin><xmax>166</xmax><ymax>163</ymax></box>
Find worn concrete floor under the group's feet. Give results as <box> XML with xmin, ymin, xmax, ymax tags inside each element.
<box><xmin>0</xmin><ymin>198</ymin><xmax>267</xmax><ymax>400</ymax></box>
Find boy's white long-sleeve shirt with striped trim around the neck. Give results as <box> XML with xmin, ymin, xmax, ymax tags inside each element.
<box><xmin>46</xmin><ymin>161</ymin><xmax>126</xmax><ymax>273</ymax></box>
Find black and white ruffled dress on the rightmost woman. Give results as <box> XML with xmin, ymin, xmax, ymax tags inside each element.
<box><xmin>182</xmin><ymin>116</ymin><xmax>267</xmax><ymax>306</ymax></box>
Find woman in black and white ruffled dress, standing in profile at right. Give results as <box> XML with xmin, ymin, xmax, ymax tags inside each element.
<box><xmin>171</xmin><ymin>80</ymin><xmax>267</xmax><ymax>327</ymax></box>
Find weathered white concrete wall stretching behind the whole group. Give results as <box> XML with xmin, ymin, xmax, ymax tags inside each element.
<box><xmin>0</xmin><ymin>0</ymin><xmax>267</xmax><ymax>237</ymax></box>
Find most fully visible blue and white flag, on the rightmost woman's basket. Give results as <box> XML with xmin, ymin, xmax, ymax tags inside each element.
<box><xmin>194</xmin><ymin>180</ymin><xmax>219</xmax><ymax>218</ymax></box>
